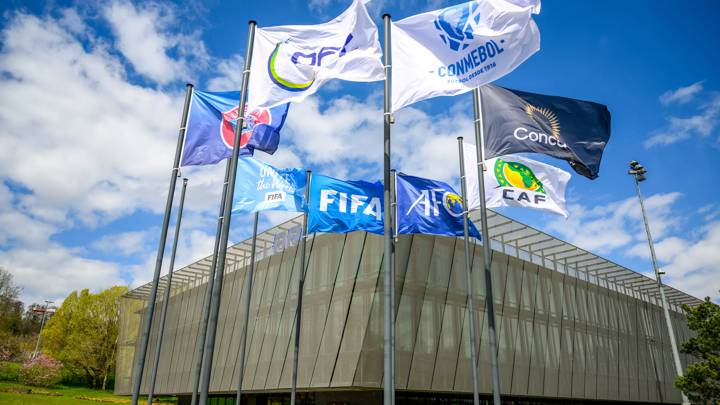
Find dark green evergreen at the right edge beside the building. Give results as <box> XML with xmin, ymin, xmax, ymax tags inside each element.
<box><xmin>675</xmin><ymin>297</ymin><xmax>720</xmax><ymax>403</ymax></box>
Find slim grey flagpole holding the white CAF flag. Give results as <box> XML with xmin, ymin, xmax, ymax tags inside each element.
<box><xmin>458</xmin><ymin>136</ymin><xmax>484</xmax><ymax>405</ymax></box>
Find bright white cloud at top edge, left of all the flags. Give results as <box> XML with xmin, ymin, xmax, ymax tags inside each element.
<box><xmin>103</xmin><ymin>1</ymin><xmax>208</xmax><ymax>84</ymax></box>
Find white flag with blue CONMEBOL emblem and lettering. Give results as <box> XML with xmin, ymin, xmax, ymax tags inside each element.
<box><xmin>392</xmin><ymin>0</ymin><xmax>540</xmax><ymax>111</ymax></box>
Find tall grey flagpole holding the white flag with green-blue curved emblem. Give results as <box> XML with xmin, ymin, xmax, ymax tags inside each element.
<box><xmin>200</xmin><ymin>21</ymin><xmax>257</xmax><ymax>405</ymax></box>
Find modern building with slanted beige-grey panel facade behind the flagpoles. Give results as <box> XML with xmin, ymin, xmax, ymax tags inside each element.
<box><xmin>115</xmin><ymin>212</ymin><xmax>700</xmax><ymax>405</ymax></box>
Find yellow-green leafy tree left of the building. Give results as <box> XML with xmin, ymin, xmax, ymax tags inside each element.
<box><xmin>43</xmin><ymin>286</ymin><xmax>127</xmax><ymax>389</ymax></box>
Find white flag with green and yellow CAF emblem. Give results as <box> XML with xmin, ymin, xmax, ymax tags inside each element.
<box><xmin>463</xmin><ymin>143</ymin><xmax>570</xmax><ymax>218</ymax></box>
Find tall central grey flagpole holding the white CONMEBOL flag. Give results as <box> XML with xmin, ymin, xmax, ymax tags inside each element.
<box><xmin>383</xmin><ymin>14</ymin><xmax>395</xmax><ymax>405</ymax></box>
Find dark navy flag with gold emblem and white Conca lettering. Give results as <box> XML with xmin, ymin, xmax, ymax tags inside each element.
<box><xmin>480</xmin><ymin>85</ymin><xmax>610</xmax><ymax>179</ymax></box>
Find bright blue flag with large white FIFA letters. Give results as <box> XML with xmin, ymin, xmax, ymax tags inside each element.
<box><xmin>308</xmin><ymin>175</ymin><xmax>383</xmax><ymax>235</ymax></box>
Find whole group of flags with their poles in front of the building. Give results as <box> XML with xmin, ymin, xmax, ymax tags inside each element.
<box><xmin>126</xmin><ymin>0</ymin><xmax>610</xmax><ymax>405</ymax></box>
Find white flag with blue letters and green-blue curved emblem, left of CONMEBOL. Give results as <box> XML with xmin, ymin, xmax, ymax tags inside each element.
<box><xmin>248</xmin><ymin>0</ymin><xmax>385</xmax><ymax>108</ymax></box>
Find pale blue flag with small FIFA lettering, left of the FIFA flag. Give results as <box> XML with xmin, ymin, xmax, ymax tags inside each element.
<box><xmin>232</xmin><ymin>157</ymin><xmax>306</xmax><ymax>214</ymax></box>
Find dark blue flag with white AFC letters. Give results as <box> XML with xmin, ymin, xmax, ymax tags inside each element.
<box><xmin>396</xmin><ymin>174</ymin><xmax>480</xmax><ymax>238</ymax></box>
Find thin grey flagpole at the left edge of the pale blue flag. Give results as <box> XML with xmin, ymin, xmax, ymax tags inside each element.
<box><xmin>190</xmin><ymin>159</ymin><xmax>230</xmax><ymax>405</ymax></box>
